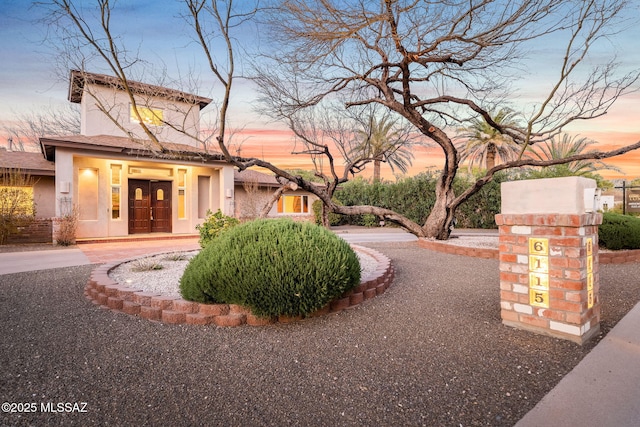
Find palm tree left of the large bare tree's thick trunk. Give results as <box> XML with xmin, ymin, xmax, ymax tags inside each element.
<box><xmin>352</xmin><ymin>114</ymin><xmax>413</xmax><ymax>182</ymax></box>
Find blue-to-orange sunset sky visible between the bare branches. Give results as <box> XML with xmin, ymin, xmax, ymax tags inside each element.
<box><xmin>0</xmin><ymin>0</ymin><xmax>640</xmax><ymax>179</ymax></box>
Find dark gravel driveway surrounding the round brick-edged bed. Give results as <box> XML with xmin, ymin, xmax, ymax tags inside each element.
<box><xmin>0</xmin><ymin>243</ymin><xmax>640</xmax><ymax>426</ymax></box>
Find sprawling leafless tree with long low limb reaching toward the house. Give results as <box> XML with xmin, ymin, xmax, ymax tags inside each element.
<box><xmin>41</xmin><ymin>0</ymin><xmax>640</xmax><ymax>239</ymax></box>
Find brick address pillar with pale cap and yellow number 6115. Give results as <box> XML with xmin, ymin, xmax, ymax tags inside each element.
<box><xmin>496</xmin><ymin>177</ymin><xmax>602</xmax><ymax>344</ymax></box>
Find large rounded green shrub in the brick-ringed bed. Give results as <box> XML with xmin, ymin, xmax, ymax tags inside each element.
<box><xmin>180</xmin><ymin>219</ymin><xmax>360</xmax><ymax>316</ymax></box>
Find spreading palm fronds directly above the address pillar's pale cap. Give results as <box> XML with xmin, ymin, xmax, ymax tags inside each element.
<box><xmin>528</xmin><ymin>134</ymin><xmax>621</xmax><ymax>178</ymax></box>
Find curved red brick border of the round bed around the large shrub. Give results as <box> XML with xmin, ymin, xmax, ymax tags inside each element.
<box><xmin>84</xmin><ymin>245</ymin><xmax>395</xmax><ymax>326</ymax></box>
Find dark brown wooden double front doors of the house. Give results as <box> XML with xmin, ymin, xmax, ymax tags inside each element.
<box><xmin>129</xmin><ymin>179</ymin><xmax>172</xmax><ymax>234</ymax></box>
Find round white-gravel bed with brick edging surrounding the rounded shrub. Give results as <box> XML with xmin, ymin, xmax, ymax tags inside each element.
<box><xmin>85</xmin><ymin>245</ymin><xmax>394</xmax><ymax>326</ymax></box>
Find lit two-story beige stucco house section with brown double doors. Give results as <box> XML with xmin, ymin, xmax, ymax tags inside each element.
<box><xmin>40</xmin><ymin>71</ymin><xmax>234</xmax><ymax>242</ymax></box>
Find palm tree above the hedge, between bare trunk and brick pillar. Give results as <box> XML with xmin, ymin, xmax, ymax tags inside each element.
<box><xmin>456</xmin><ymin>108</ymin><xmax>521</xmax><ymax>170</ymax></box>
